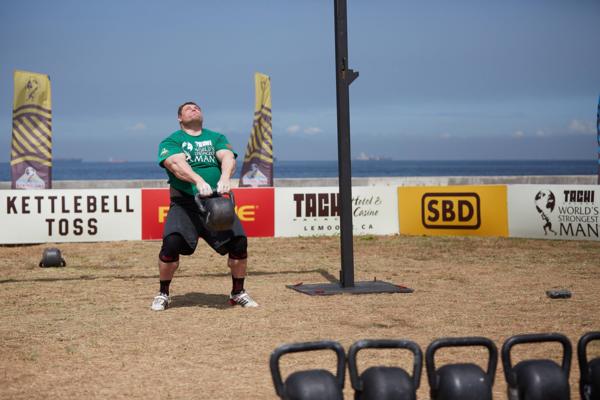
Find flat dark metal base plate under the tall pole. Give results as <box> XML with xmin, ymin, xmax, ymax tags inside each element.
<box><xmin>286</xmin><ymin>281</ymin><xmax>414</xmax><ymax>296</ymax></box>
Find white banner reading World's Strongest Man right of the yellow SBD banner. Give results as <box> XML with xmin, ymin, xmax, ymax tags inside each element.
<box><xmin>508</xmin><ymin>185</ymin><xmax>600</xmax><ymax>240</ymax></box>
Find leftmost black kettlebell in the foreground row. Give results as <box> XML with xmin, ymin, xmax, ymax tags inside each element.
<box><xmin>269</xmin><ymin>341</ymin><xmax>346</xmax><ymax>400</ymax></box>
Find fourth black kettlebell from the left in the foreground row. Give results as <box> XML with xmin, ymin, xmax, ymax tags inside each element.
<box><xmin>502</xmin><ymin>333</ymin><xmax>572</xmax><ymax>400</ymax></box>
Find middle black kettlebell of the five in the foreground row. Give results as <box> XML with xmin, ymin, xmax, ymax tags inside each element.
<box><xmin>425</xmin><ymin>337</ymin><xmax>498</xmax><ymax>400</ymax></box>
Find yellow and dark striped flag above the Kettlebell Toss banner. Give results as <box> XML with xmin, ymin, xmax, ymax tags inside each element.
<box><xmin>10</xmin><ymin>71</ymin><xmax>52</xmax><ymax>189</ymax></box>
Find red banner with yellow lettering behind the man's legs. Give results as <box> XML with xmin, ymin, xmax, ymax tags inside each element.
<box><xmin>142</xmin><ymin>188</ymin><xmax>275</xmax><ymax>240</ymax></box>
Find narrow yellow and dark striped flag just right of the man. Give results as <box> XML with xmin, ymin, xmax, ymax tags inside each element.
<box><xmin>239</xmin><ymin>73</ymin><xmax>273</xmax><ymax>187</ymax></box>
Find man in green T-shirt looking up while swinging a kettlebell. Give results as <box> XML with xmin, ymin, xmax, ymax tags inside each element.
<box><xmin>151</xmin><ymin>102</ymin><xmax>258</xmax><ymax>311</ymax></box>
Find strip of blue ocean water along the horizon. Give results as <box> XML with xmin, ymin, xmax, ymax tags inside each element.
<box><xmin>0</xmin><ymin>160</ymin><xmax>598</xmax><ymax>181</ymax></box>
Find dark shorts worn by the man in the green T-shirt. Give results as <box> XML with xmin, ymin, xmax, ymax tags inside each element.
<box><xmin>163</xmin><ymin>190</ymin><xmax>246</xmax><ymax>255</ymax></box>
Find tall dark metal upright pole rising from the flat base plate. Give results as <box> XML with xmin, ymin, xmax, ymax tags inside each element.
<box><xmin>334</xmin><ymin>0</ymin><xmax>358</xmax><ymax>288</ymax></box>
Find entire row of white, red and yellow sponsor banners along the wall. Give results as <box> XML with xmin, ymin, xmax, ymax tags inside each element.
<box><xmin>0</xmin><ymin>184</ymin><xmax>600</xmax><ymax>244</ymax></box>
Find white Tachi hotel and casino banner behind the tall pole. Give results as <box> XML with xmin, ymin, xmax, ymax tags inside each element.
<box><xmin>275</xmin><ymin>186</ymin><xmax>399</xmax><ymax>236</ymax></box>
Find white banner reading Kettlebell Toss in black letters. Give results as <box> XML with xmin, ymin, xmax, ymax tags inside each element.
<box><xmin>0</xmin><ymin>189</ymin><xmax>142</xmax><ymax>244</ymax></box>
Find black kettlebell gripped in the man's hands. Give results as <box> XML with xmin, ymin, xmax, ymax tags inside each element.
<box><xmin>194</xmin><ymin>191</ymin><xmax>235</xmax><ymax>231</ymax></box>
